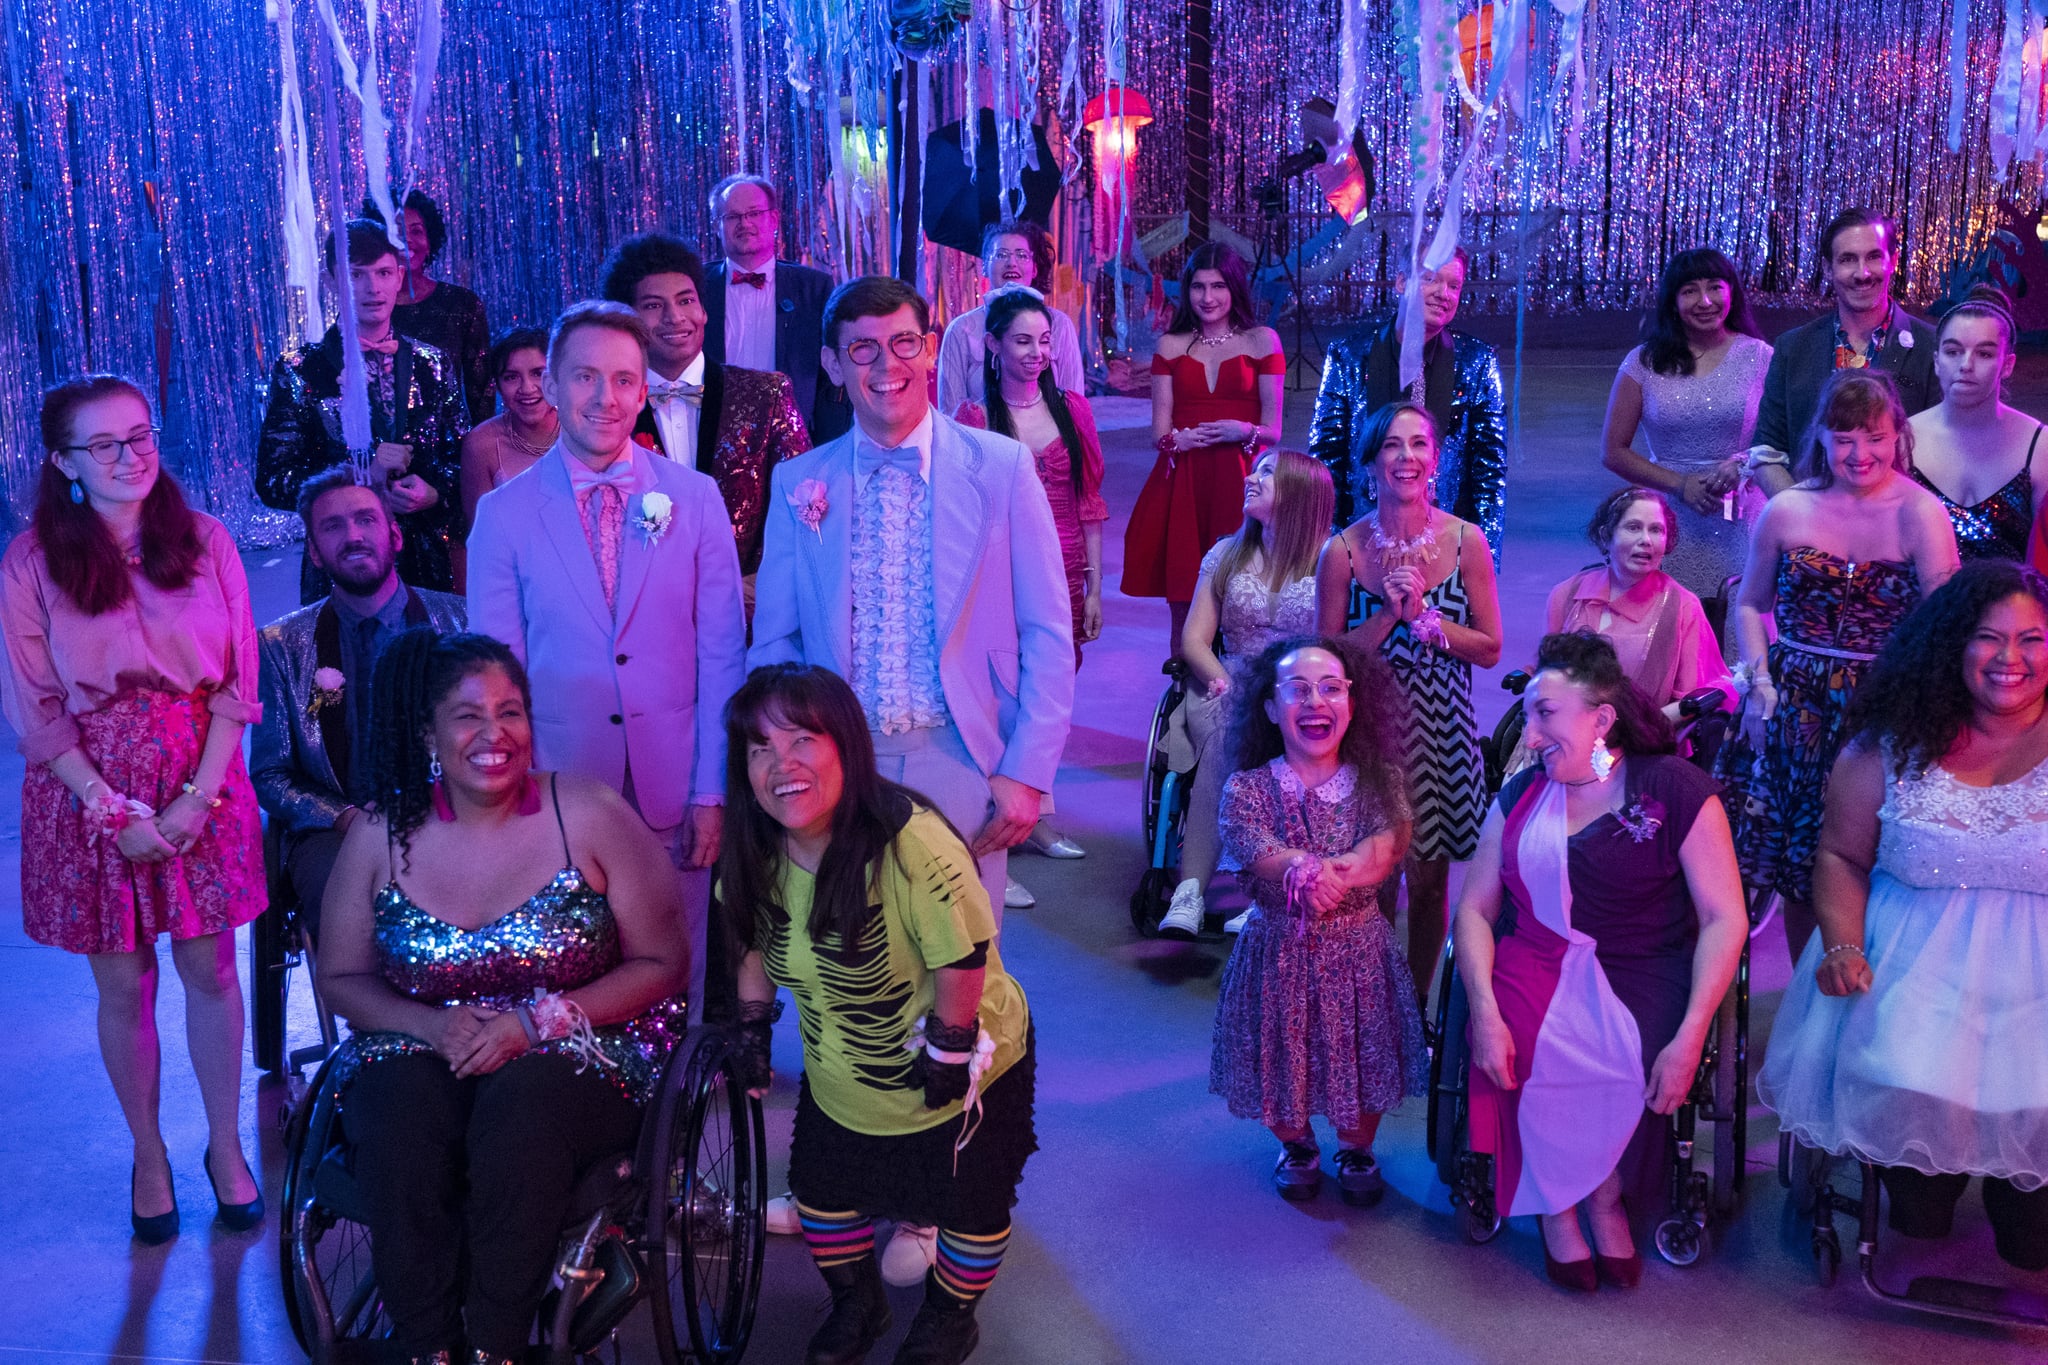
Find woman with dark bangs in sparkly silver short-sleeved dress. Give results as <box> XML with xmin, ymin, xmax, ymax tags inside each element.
<box><xmin>1602</xmin><ymin>246</ymin><xmax>1772</xmax><ymax>598</ymax></box>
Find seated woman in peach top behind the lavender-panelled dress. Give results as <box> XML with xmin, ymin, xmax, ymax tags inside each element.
<box><xmin>1544</xmin><ymin>487</ymin><xmax>1735</xmax><ymax>718</ymax></box>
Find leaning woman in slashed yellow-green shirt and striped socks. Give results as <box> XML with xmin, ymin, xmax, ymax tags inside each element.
<box><xmin>719</xmin><ymin>663</ymin><xmax>1038</xmax><ymax>1365</ymax></box>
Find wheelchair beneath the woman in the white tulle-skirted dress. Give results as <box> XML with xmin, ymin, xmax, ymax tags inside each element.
<box><xmin>1778</xmin><ymin>1132</ymin><xmax>2048</xmax><ymax>1328</ymax></box>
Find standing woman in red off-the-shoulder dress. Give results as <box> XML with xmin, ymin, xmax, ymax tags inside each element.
<box><xmin>1122</xmin><ymin>241</ymin><xmax>1286</xmax><ymax>657</ymax></box>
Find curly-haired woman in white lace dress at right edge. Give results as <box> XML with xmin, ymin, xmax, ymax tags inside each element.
<box><xmin>1757</xmin><ymin>561</ymin><xmax>2048</xmax><ymax>1271</ymax></box>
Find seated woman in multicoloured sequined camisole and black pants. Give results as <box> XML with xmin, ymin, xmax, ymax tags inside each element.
<box><xmin>319</xmin><ymin>628</ymin><xmax>688</xmax><ymax>1365</ymax></box>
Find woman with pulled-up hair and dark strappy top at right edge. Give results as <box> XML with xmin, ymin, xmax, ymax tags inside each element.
<box><xmin>1913</xmin><ymin>284</ymin><xmax>2048</xmax><ymax>563</ymax></box>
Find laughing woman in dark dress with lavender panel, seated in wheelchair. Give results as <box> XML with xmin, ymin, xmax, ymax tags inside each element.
<box><xmin>1456</xmin><ymin>632</ymin><xmax>1749</xmax><ymax>1291</ymax></box>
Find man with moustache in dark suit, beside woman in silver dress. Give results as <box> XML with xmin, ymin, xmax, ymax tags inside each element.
<box><xmin>1749</xmin><ymin>209</ymin><xmax>1942</xmax><ymax>493</ymax></box>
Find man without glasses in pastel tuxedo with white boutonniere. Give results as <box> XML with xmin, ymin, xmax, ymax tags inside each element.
<box><xmin>469</xmin><ymin>303</ymin><xmax>745</xmax><ymax>1013</ymax></box>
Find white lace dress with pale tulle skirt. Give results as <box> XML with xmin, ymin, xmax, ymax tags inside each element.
<box><xmin>1757</xmin><ymin>761</ymin><xmax>2048</xmax><ymax>1189</ymax></box>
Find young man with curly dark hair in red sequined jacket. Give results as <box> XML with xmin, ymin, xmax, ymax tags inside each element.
<box><xmin>602</xmin><ymin>231</ymin><xmax>811</xmax><ymax>620</ymax></box>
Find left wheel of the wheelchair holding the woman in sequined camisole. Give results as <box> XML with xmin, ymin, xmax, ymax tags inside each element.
<box><xmin>279</xmin><ymin>1052</ymin><xmax>391</xmax><ymax>1363</ymax></box>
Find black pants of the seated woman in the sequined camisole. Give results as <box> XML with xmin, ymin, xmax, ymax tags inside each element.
<box><xmin>342</xmin><ymin>1052</ymin><xmax>641</xmax><ymax>1357</ymax></box>
